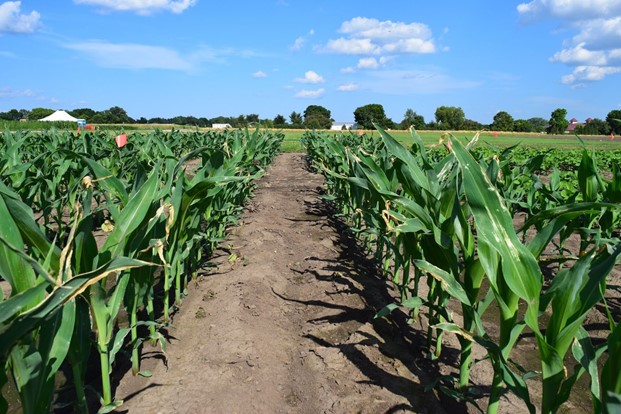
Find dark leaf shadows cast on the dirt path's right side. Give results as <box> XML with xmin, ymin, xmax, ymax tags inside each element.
<box><xmin>274</xmin><ymin>177</ymin><xmax>472</xmax><ymax>413</ymax></box>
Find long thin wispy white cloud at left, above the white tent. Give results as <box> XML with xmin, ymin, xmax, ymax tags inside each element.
<box><xmin>66</xmin><ymin>41</ymin><xmax>193</xmax><ymax>71</ymax></box>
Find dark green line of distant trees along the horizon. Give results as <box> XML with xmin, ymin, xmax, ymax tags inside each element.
<box><xmin>0</xmin><ymin>104</ymin><xmax>621</xmax><ymax>135</ymax></box>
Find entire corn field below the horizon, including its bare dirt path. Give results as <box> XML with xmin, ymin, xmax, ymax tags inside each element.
<box><xmin>0</xmin><ymin>128</ymin><xmax>621</xmax><ymax>414</ymax></box>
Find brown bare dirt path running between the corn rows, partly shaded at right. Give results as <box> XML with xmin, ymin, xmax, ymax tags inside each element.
<box><xmin>116</xmin><ymin>154</ymin><xmax>443</xmax><ymax>413</ymax></box>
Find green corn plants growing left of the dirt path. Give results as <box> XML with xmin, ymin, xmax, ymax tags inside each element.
<box><xmin>0</xmin><ymin>130</ymin><xmax>283</xmax><ymax>413</ymax></box>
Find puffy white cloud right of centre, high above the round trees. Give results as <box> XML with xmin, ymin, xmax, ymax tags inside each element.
<box><xmin>318</xmin><ymin>17</ymin><xmax>436</xmax><ymax>55</ymax></box>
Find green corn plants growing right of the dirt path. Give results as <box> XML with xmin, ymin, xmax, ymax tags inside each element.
<box><xmin>303</xmin><ymin>128</ymin><xmax>621</xmax><ymax>413</ymax></box>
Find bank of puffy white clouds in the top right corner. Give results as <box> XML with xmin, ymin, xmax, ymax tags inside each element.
<box><xmin>517</xmin><ymin>0</ymin><xmax>621</xmax><ymax>84</ymax></box>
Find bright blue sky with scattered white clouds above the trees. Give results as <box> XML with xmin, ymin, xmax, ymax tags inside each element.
<box><xmin>0</xmin><ymin>0</ymin><xmax>621</xmax><ymax>123</ymax></box>
